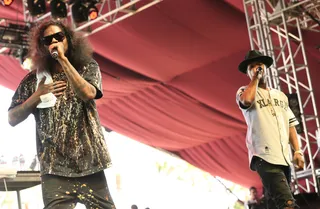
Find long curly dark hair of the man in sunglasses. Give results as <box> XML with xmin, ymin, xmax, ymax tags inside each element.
<box><xmin>29</xmin><ymin>19</ymin><xmax>93</xmax><ymax>70</ymax></box>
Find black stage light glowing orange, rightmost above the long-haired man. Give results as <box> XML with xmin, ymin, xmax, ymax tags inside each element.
<box><xmin>72</xmin><ymin>0</ymin><xmax>98</xmax><ymax>23</ymax></box>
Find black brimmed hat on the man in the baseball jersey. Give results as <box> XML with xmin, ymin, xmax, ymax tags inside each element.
<box><xmin>238</xmin><ymin>50</ymin><xmax>273</xmax><ymax>74</ymax></box>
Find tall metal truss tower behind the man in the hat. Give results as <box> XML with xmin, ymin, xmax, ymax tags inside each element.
<box><xmin>243</xmin><ymin>0</ymin><xmax>320</xmax><ymax>193</ymax></box>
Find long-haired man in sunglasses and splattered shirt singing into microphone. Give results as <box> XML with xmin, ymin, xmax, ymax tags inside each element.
<box><xmin>8</xmin><ymin>20</ymin><xmax>115</xmax><ymax>209</ymax></box>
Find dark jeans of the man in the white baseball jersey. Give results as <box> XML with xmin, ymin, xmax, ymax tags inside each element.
<box><xmin>254</xmin><ymin>157</ymin><xmax>299</xmax><ymax>209</ymax></box>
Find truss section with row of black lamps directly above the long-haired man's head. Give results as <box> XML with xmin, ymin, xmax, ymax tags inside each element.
<box><xmin>23</xmin><ymin>0</ymin><xmax>162</xmax><ymax>36</ymax></box>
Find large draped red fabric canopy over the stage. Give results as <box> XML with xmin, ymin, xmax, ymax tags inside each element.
<box><xmin>0</xmin><ymin>0</ymin><xmax>320</xmax><ymax>187</ymax></box>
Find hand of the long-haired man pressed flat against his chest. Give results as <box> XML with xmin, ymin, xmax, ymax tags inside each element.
<box><xmin>36</xmin><ymin>77</ymin><xmax>67</xmax><ymax>97</ymax></box>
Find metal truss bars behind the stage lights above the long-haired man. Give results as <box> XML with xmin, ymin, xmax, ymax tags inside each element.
<box><xmin>23</xmin><ymin>0</ymin><xmax>162</xmax><ymax>36</ymax></box>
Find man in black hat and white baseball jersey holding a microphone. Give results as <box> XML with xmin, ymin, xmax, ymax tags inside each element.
<box><xmin>236</xmin><ymin>50</ymin><xmax>304</xmax><ymax>209</ymax></box>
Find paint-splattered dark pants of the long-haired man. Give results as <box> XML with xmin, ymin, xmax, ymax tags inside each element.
<box><xmin>41</xmin><ymin>171</ymin><xmax>116</xmax><ymax>209</ymax></box>
